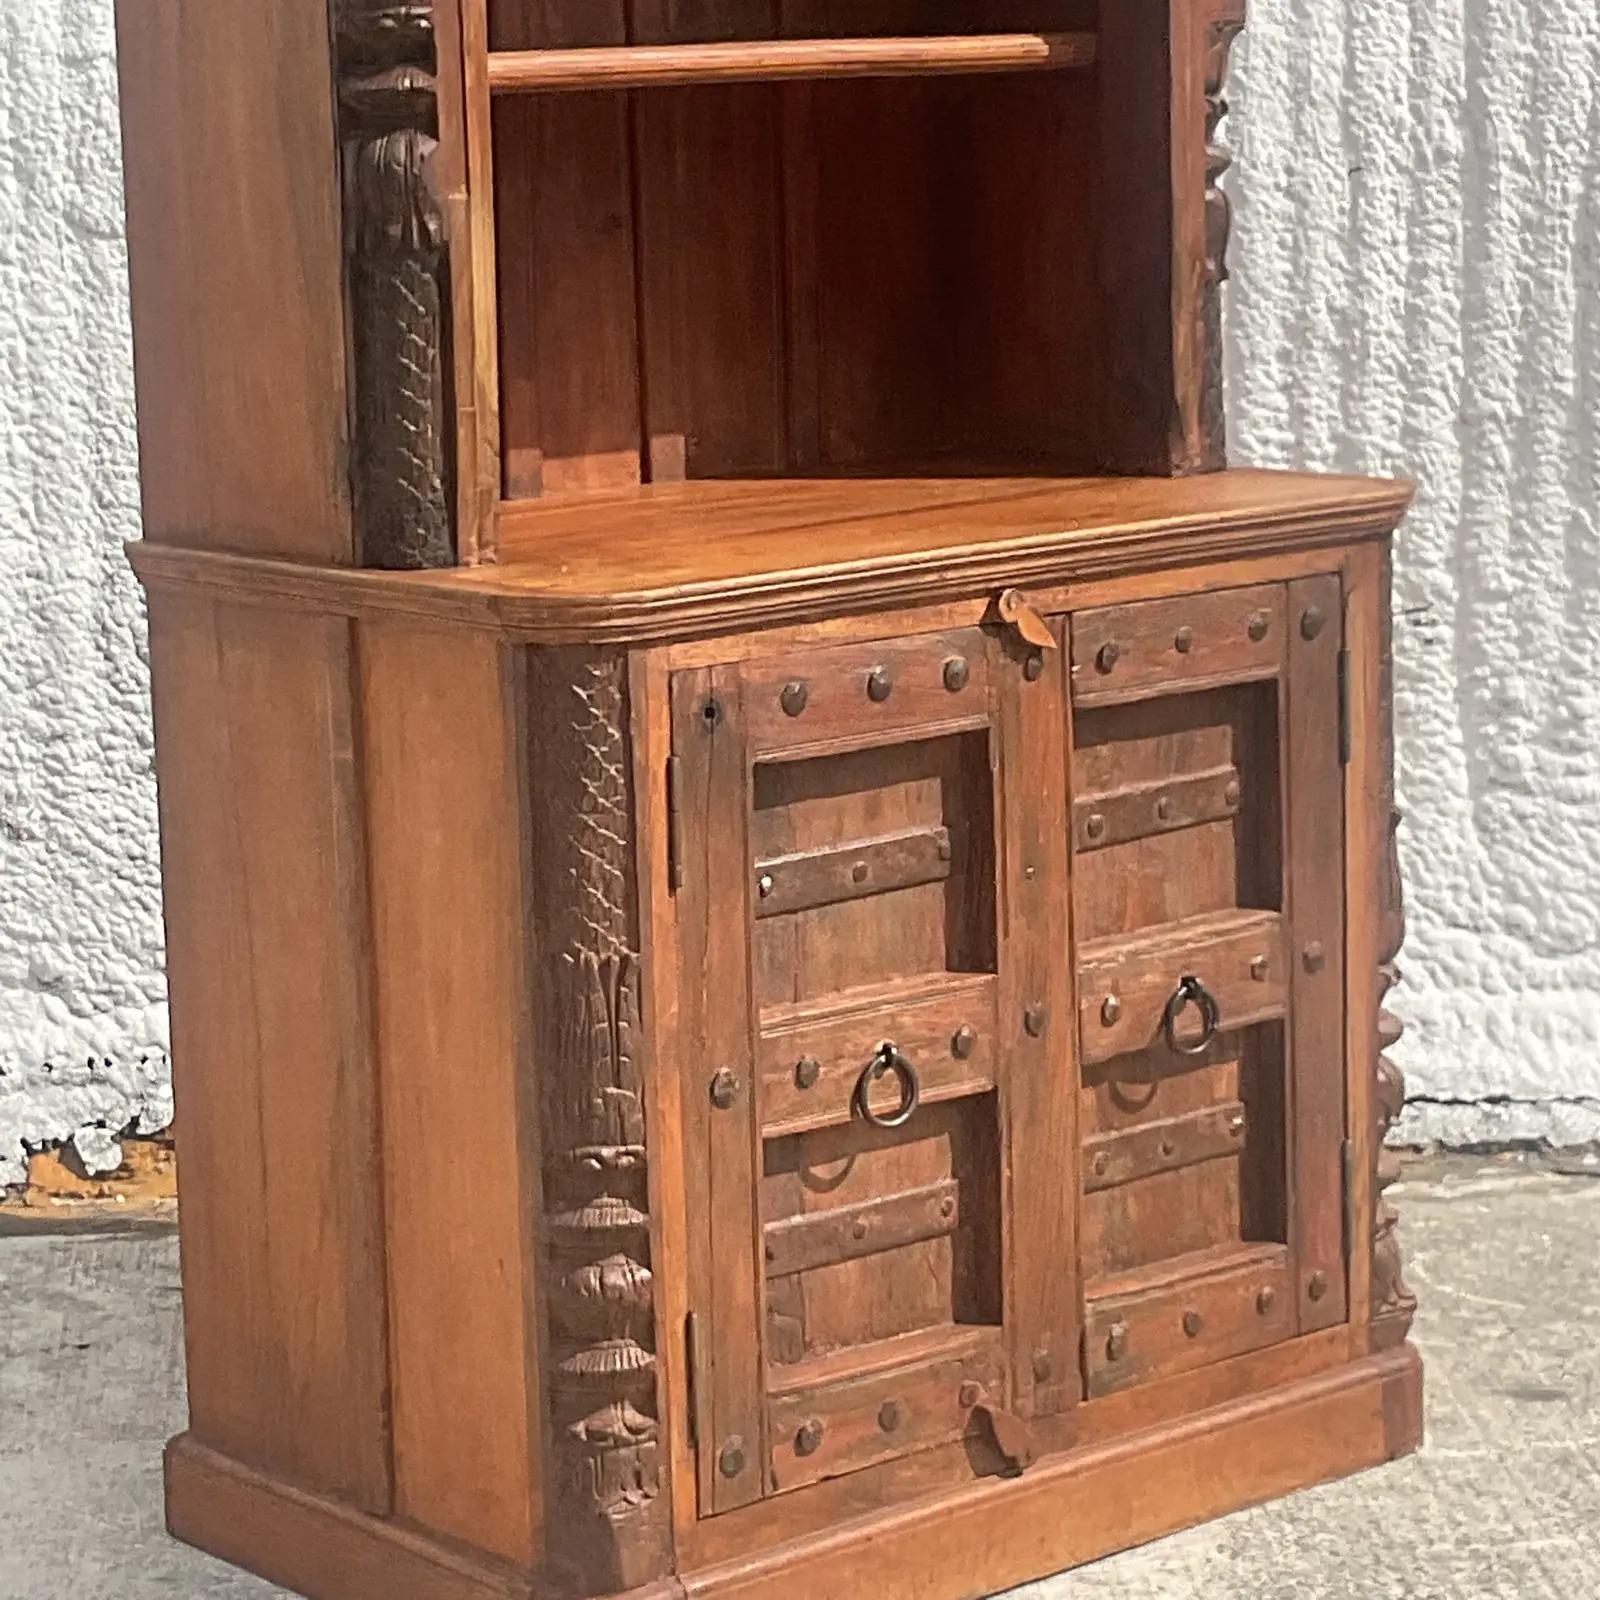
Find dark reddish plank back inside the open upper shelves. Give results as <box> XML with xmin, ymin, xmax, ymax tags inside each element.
<box><xmin>490</xmin><ymin>0</ymin><xmax>1104</xmax><ymax>501</ymax></box>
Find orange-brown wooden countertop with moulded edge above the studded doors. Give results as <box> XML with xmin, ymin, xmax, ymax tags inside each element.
<box><xmin>133</xmin><ymin>469</ymin><xmax>1413</xmax><ymax>642</ymax></box>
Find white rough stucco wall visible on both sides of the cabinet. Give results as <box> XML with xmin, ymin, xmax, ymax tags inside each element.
<box><xmin>0</xmin><ymin>0</ymin><xmax>1600</xmax><ymax>1182</ymax></box>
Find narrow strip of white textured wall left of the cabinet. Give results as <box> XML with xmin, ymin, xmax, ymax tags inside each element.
<box><xmin>0</xmin><ymin>0</ymin><xmax>170</xmax><ymax>1182</ymax></box>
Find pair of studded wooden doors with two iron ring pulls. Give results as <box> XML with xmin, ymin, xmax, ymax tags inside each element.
<box><xmin>669</xmin><ymin>576</ymin><xmax>1347</xmax><ymax>1517</ymax></box>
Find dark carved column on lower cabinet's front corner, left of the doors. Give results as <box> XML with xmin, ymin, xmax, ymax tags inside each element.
<box><xmin>528</xmin><ymin>648</ymin><xmax>669</xmax><ymax>1594</ymax></box>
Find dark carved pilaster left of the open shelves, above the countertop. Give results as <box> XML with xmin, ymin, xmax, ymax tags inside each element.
<box><xmin>333</xmin><ymin>0</ymin><xmax>454</xmax><ymax>568</ymax></box>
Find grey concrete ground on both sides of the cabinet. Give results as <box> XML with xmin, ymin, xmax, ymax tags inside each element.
<box><xmin>0</xmin><ymin>1158</ymin><xmax>1600</xmax><ymax>1600</ymax></box>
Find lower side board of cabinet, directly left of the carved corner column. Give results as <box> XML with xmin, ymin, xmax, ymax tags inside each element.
<box><xmin>360</xmin><ymin>624</ymin><xmax>541</xmax><ymax>1566</ymax></box>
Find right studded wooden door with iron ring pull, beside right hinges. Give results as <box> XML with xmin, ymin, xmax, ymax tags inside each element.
<box><xmin>1069</xmin><ymin>576</ymin><xmax>1346</xmax><ymax>1395</ymax></box>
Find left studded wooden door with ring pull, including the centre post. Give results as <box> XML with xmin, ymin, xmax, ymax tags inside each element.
<box><xmin>674</xmin><ymin>629</ymin><xmax>1082</xmax><ymax>1515</ymax></box>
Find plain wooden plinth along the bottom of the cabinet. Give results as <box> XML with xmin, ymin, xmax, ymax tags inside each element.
<box><xmin>166</xmin><ymin>1344</ymin><xmax>1422</xmax><ymax>1600</ymax></box>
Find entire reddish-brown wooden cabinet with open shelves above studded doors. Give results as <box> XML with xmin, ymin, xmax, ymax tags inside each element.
<box><xmin>118</xmin><ymin>0</ymin><xmax>1421</xmax><ymax>1600</ymax></box>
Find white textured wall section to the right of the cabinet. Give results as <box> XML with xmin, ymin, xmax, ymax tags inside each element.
<box><xmin>1229</xmin><ymin>0</ymin><xmax>1600</xmax><ymax>1141</ymax></box>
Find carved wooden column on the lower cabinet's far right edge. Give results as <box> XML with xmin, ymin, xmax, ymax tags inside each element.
<box><xmin>1373</xmin><ymin>565</ymin><xmax>1416</xmax><ymax>1350</ymax></box>
